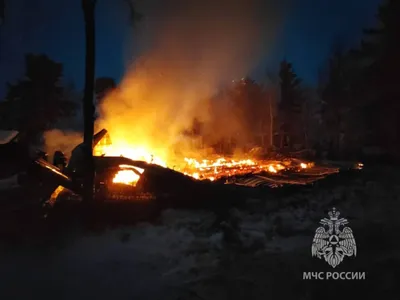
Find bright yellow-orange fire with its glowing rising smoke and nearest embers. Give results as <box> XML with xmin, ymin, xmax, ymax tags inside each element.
<box><xmin>87</xmin><ymin>1</ymin><xmax>308</xmax><ymax>186</ymax></box>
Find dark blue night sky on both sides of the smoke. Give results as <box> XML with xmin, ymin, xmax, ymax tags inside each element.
<box><xmin>0</xmin><ymin>0</ymin><xmax>380</xmax><ymax>97</ymax></box>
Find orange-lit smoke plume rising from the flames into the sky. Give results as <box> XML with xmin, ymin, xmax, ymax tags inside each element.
<box><xmin>97</xmin><ymin>0</ymin><xmax>284</xmax><ymax>164</ymax></box>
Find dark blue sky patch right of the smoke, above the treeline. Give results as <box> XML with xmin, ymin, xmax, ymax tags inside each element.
<box><xmin>277</xmin><ymin>0</ymin><xmax>382</xmax><ymax>82</ymax></box>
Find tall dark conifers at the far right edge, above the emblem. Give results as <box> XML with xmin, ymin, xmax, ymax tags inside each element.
<box><xmin>319</xmin><ymin>0</ymin><xmax>400</xmax><ymax>158</ymax></box>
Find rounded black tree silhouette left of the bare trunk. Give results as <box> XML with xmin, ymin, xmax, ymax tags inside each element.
<box><xmin>3</xmin><ymin>54</ymin><xmax>78</xmax><ymax>142</ymax></box>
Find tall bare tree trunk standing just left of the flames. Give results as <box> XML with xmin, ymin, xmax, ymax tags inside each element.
<box><xmin>82</xmin><ymin>0</ymin><xmax>96</xmax><ymax>203</ymax></box>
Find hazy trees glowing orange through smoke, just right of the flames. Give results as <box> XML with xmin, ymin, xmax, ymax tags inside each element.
<box><xmin>203</xmin><ymin>77</ymin><xmax>273</xmax><ymax>154</ymax></box>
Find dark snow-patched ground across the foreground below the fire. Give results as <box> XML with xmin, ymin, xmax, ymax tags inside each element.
<box><xmin>0</xmin><ymin>166</ymin><xmax>400</xmax><ymax>300</ymax></box>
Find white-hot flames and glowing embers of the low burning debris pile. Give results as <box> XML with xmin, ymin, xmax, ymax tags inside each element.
<box><xmin>94</xmin><ymin>130</ymin><xmax>352</xmax><ymax>187</ymax></box>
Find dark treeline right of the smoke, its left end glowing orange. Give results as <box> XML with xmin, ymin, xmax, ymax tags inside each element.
<box><xmin>191</xmin><ymin>0</ymin><xmax>400</xmax><ymax>159</ymax></box>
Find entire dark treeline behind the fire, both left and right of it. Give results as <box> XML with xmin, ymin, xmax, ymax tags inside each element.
<box><xmin>0</xmin><ymin>0</ymin><xmax>400</xmax><ymax>159</ymax></box>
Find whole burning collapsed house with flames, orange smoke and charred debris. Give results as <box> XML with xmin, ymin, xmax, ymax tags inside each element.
<box><xmin>0</xmin><ymin>2</ymin><xmax>364</xmax><ymax>213</ymax></box>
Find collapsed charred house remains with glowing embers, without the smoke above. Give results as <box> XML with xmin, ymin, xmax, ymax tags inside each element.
<box><xmin>1</xmin><ymin>123</ymin><xmax>361</xmax><ymax>211</ymax></box>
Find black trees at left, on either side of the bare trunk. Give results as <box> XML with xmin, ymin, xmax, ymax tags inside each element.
<box><xmin>0</xmin><ymin>54</ymin><xmax>116</xmax><ymax>143</ymax></box>
